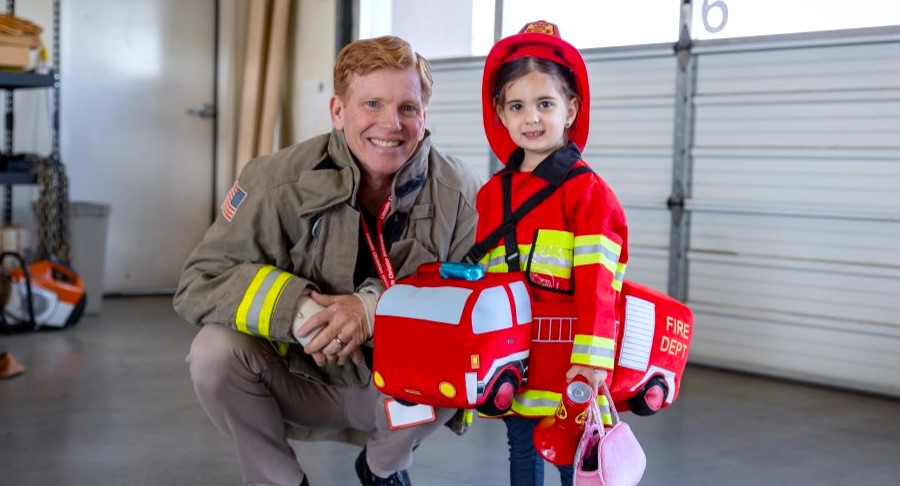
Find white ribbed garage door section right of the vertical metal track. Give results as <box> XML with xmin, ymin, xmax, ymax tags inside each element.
<box><xmin>687</xmin><ymin>37</ymin><xmax>900</xmax><ymax>395</ymax></box>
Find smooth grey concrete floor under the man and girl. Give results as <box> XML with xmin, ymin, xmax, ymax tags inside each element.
<box><xmin>0</xmin><ymin>297</ymin><xmax>900</xmax><ymax>486</ymax></box>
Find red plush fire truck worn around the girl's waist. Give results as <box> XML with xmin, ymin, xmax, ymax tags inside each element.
<box><xmin>373</xmin><ymin>263</ymin><xmax>693</xmax><ymax>416</ymax></box>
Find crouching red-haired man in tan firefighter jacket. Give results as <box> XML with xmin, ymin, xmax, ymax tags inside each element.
<box><xmin>174</xmin><ymin>36</ymin><xmax>479</xmax><ymax>485</ymax></box>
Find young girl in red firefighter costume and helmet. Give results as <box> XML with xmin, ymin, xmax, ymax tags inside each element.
<box><xmin>476</xmin><ymin>21</ymin><xmax>628</xmax><ymax>486</ymax></box>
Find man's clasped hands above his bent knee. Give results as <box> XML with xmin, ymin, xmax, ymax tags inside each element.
<box><xmin>297</xmin><ymin>291</ymin><xmax>370</xmax><ymax>366</ymax></box>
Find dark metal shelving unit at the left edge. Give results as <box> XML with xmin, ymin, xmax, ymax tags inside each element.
<box><xmin>0</xmin><ymin>0</ymin><xmax>60</xmax><ymax>226</ymax></box>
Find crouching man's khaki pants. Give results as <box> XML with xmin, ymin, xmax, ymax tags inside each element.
<box><xmin>187</xmin><ymin>325</ymin><xmax>454</xmax><ymax>486</ymax></box>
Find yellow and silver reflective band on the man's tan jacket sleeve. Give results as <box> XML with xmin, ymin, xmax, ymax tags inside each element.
<box><xmin>235</xmin><ymin>265</ymin><xmax>293</xmax><ymax>338</ymax></box>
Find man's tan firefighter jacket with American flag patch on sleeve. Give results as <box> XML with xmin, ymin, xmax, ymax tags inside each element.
<box><xmin>174</xmin><ymin>131</ymin><xmax>480</xmax><ymax>386</ymax></box>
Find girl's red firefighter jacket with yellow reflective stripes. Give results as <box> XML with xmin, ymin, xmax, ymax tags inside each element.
<box><xmin>475</xmin><ymin>143</ymin><xmax>628</xmax><ymax>416</ymax></box>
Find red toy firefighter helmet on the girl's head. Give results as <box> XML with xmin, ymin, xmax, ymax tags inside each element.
<box><xmin>481</xmin><ymin>20</ymin><xmax>591</xmax><ymax>164</ymax></box>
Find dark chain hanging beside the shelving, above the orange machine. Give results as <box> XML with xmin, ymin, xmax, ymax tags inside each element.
<box><xmin>31</xmin><ymin>156</ymin><xmax>71</xmax><ymax>264</ymax></box>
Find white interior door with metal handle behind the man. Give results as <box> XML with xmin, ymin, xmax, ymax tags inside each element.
<box><xmin>60</xmin><ymin>0</ymin><xmax>215</xmax><ymax>292</ymax></box>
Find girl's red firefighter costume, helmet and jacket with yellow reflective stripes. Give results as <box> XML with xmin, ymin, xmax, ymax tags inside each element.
<box><xmin>476</xmin><ymin>22</ymin><xmax>628</xmax><ymax>417</ymax></box>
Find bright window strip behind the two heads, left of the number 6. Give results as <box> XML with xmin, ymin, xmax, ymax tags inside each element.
<box><xmin>358</xmin><ymin>0</ymin><xmax>680</xmax><ymax>60</ymax></box>
